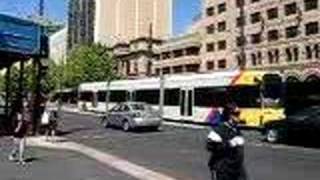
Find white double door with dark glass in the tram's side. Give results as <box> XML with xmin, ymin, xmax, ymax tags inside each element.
<box><xmin>180</xmin><ymin>88</ymin><xmax>194</xmax><ymax>117</ymax></box>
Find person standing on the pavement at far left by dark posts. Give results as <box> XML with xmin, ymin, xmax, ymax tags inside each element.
<box><xmin>9</xmin><ymin>98</ymin><xmax>31</xmax><ymax>165</ymax></box>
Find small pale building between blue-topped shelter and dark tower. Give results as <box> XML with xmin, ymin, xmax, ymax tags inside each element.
<box><xmin>49</xmin><ymin>27</ymin><xmax>68</xmax><ymax>64</ymax></box>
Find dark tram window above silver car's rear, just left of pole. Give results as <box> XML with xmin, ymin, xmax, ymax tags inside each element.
<box><xmin>135</xmin><ymin>90</ymin><xmax>160</xmax><ymax>104</ymax></box>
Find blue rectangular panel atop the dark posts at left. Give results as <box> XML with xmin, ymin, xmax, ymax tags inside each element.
<box><xmin>0</xmin><ymin>14</ymin><xmax>41</xmax><ymax>56</ymax></box>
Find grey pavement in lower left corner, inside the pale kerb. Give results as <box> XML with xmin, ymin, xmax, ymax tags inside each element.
<box><xmin>0</xmin><ymin>137</ymin><xmax>134</xmax><ymax>180</ymax></box>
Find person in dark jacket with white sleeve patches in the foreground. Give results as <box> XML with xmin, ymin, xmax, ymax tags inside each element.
<box><xmin>207</xmin><ymin>104</ymin><xmax>247</xmax><ymax>180</ymax></box>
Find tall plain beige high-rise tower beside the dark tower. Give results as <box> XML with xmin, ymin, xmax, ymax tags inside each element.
<box><xmin>94</xmin><ymin>0</ymin><xmax>172</xmax><ymax>46</ymax></box>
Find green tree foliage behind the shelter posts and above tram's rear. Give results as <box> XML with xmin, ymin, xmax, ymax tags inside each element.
<box><xmin>0</xmin><ymin>44</ymin><xmax>119</xmax><ymax>97</ymax></box>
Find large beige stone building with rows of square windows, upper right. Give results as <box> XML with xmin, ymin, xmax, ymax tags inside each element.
<box><xmin>198</xmin><ymin>0</ymin><xmax>320</xmax><ymax>80</ymax></box>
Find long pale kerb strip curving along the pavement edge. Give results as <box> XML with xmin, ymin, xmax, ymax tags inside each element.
<box><xmin>28</xmin><ymin>138</ymin><xmax>176</xmax><ymax>180</ymax></box>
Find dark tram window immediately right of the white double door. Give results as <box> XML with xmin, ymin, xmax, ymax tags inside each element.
<box><xmin>194</xmin><ymin>87</ymin><xmax>229</xmax><ymax>107</ymax></box>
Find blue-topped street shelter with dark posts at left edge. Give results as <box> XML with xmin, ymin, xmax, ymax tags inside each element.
<box><xmin>0</xmin><ymin>14</ymin><xmax>48</xmax><ymax>132</ymax></box>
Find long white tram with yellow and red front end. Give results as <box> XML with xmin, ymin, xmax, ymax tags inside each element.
<box><xmin>78</xmin><ymin>70</ymin><xmax>285</xmax><ymax>127</ymax></box>
